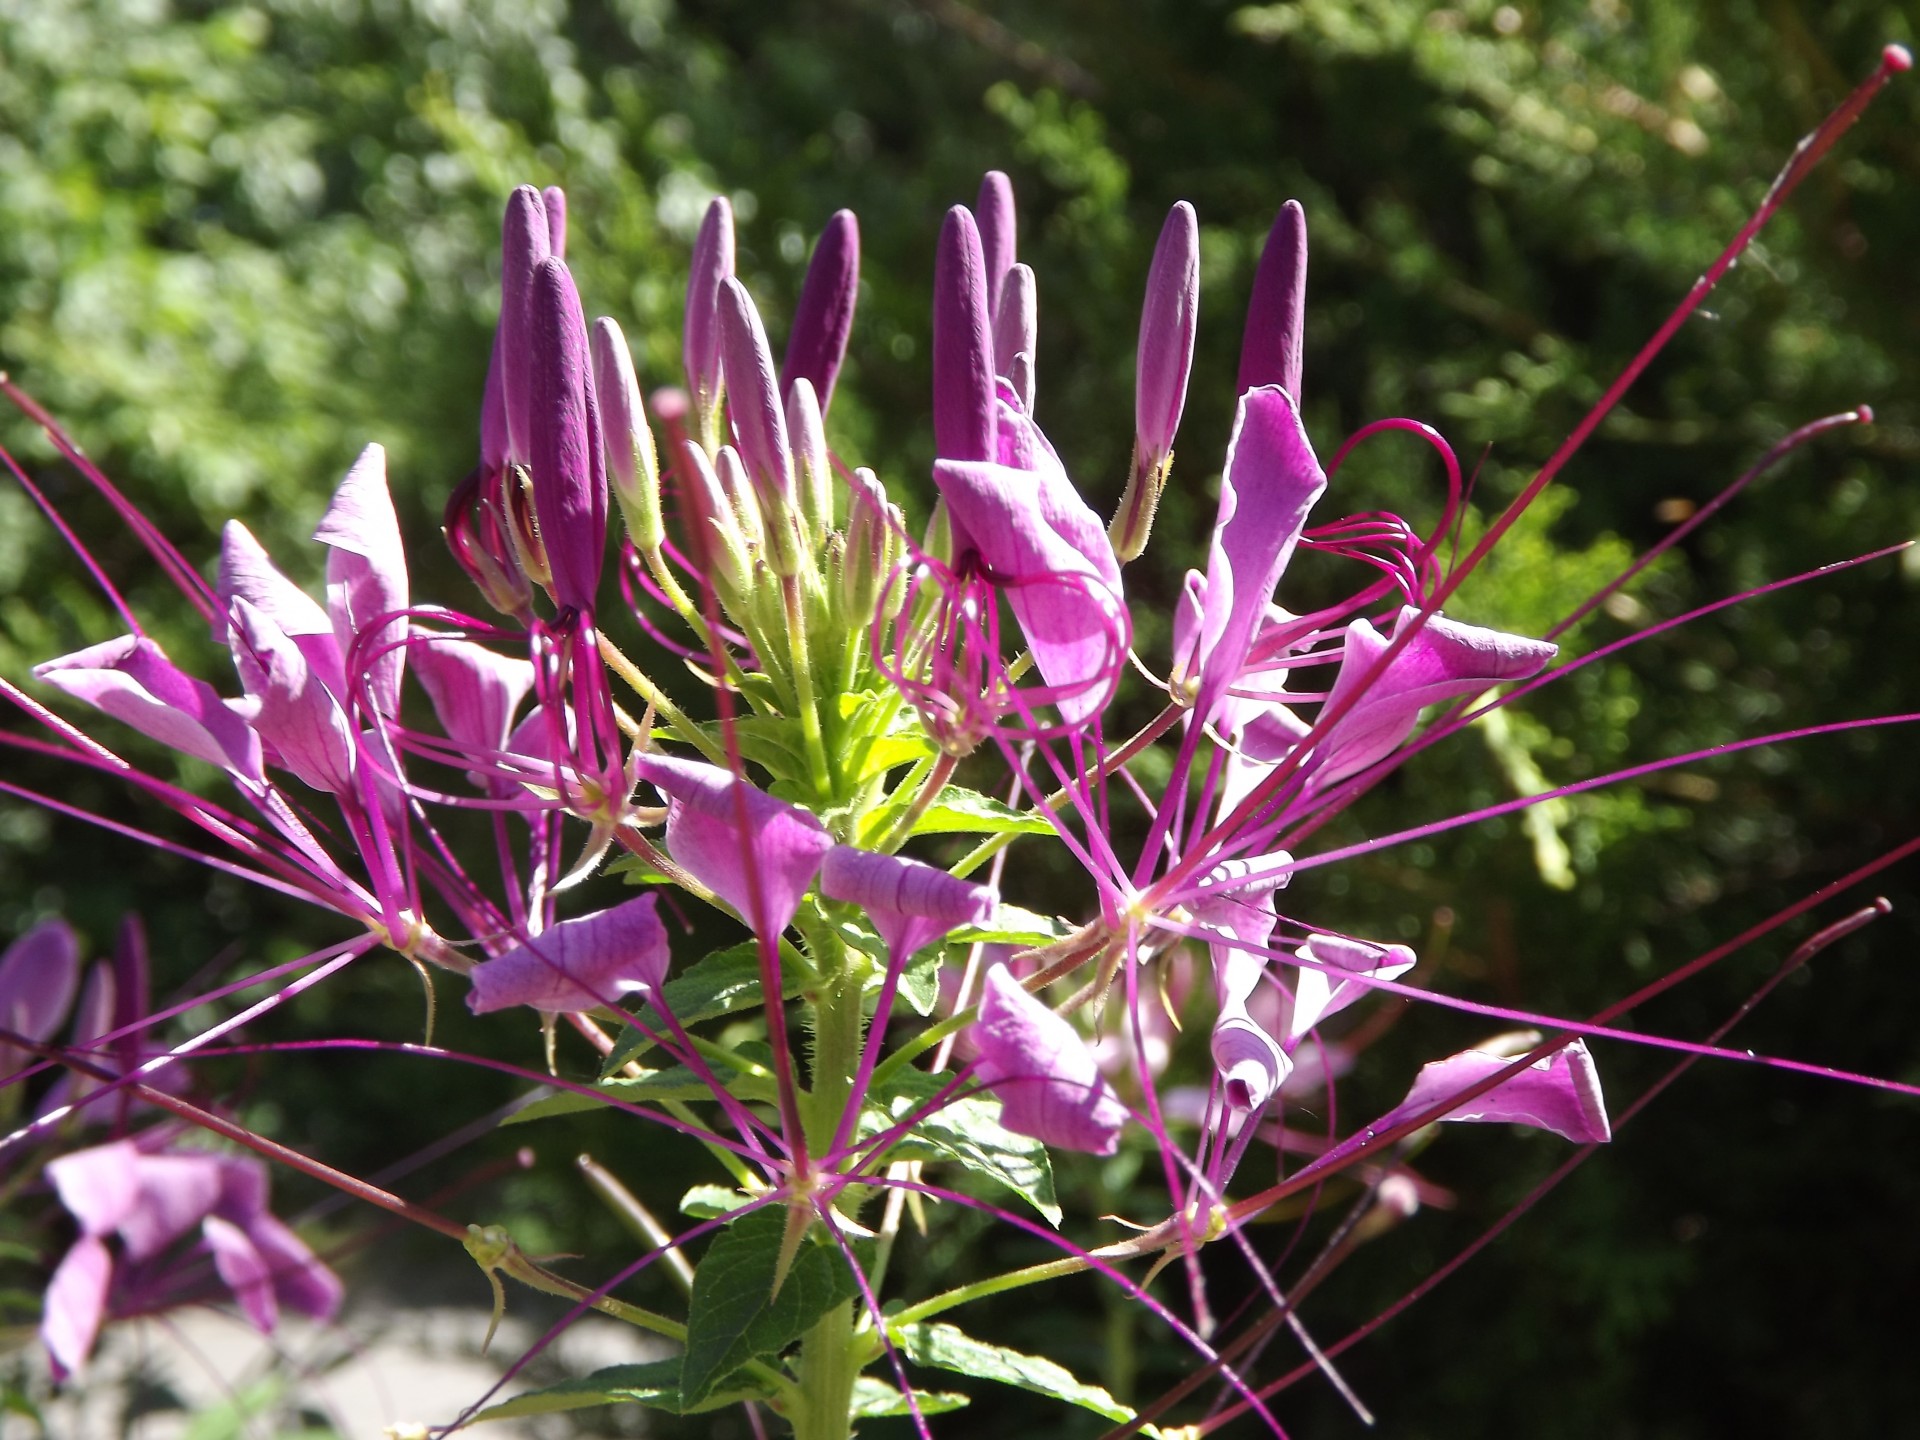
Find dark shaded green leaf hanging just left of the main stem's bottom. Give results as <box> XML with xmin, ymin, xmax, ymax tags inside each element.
<box><xmin>680</xmin><ymin>1206</ymin><xmax>858</xmax><ymax>1405</ymax></box>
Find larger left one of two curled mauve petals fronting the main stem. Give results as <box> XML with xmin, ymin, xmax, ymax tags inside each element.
<box><xmin>634</xmin><ymin>755</ymin><xmax>833</xmax><ymax>933</ymax></box>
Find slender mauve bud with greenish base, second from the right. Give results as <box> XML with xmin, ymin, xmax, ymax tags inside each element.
<box><xmin>1112</xmin><ymin>200</ymin><xmax>1200</xmax><ymax>561</ymax></box>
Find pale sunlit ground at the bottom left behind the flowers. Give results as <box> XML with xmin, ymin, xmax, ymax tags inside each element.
<box><xmin>24</xmin><ymin>1302</ymin><xmax>662</xmax><ymax>1440</ymax></box>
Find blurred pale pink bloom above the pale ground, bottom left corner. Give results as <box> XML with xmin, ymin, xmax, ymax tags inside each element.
<box><xmin>40</xmin><ymin>1140</ymin><xmax>342</xmax><ymax>1379</ymax></box>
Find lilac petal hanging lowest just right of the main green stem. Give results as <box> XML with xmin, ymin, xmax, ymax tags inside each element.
<box><xmin>972</xmin><ymin>966</ymin><xmax>1127</xmax><ymax>1156</ymax></box>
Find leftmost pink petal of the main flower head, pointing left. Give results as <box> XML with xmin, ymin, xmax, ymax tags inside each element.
<box><xmin>33</xmin><ymin>636</ymin><xmax>261</xmax><ymax>783</ymax></box>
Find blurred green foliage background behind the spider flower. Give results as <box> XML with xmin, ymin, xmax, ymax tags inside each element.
<box><xmin>0</xmin><ymin>0</ymin><xmax>1920</xmax><ymax>1436</ymax></box>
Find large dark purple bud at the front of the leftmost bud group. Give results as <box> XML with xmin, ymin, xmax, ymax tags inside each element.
<box><xmin>528</xmin><ymin>259</ymin><xmax>607</xmax><ymax>614</ymax></box>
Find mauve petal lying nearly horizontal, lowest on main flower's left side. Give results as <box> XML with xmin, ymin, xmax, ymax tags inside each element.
<box><xmin>467</xmin><ymin>895</ymin><xmax>668</xmax><ymax>1016</ymax></box>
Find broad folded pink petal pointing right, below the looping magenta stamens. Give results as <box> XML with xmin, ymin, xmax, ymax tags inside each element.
<box><xmin>1313</xmin><ymin>605</ymin><xmax>1557</xmax><ymax>785</ymax></box>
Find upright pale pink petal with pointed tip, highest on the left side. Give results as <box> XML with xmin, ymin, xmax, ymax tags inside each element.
<box><xmin>313</xmin><ymin>445</ymin><xmax>407</xmax><ymax>716</ymax></box>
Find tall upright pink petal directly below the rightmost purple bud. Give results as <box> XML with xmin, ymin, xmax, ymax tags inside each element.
<box><xmin>1194</xmin><ymin>386</ymin><xmax>1327</xmax><ymax>718</ymax></box>
